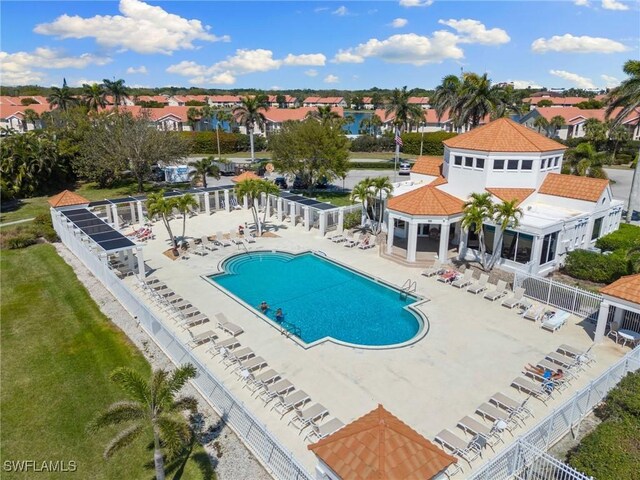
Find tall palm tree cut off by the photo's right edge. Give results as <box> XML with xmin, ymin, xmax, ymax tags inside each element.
<box><xmin>606</xmin><ymin>60</ymin><xmax>640</xmax><ymax>223</ymax></box>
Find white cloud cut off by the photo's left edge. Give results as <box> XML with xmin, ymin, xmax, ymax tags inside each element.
<box><xmin>0</xmin><ymin>47</ymin><xmax>111</xmax><ymax>85</ymax></box>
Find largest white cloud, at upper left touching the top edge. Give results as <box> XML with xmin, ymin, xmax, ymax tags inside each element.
<box><xmin>34</xmin><ymin>0</ymin><xmax>230</xmax><ymax>55</ymax></box>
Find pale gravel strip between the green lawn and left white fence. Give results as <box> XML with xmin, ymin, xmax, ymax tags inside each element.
<box><xmin>54</xmin><ymin>243</ymin><xmax>272</xmax><ymax>480</ymax></box>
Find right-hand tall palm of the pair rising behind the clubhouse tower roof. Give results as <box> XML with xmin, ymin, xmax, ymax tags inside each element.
<box><xmin>453</xmin><ymin>73</ymin><xmax>502</xmax><ymax>128</ymax></box>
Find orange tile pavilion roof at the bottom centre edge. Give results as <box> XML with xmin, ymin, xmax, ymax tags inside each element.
<box><xmin>307</xmin><ymin>405</ymin><xmax>457</xmax><ymax>480</ymax></box>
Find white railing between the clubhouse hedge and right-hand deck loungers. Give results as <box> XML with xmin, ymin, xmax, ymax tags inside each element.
<box><xmin>513</xmin><ymin>271</ymin><xmax>602</xmax><ymax>318</ymax></box>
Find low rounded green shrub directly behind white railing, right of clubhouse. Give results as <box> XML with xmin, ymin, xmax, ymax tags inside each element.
<box><xmin>564</xmin><ymin>250</ymin><xmax>628</xmax><ymax>283</ymax></box>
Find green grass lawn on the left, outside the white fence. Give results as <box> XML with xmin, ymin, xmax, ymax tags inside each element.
<box><xmin>0</xmin><ymin>245</ymin><xmax>214</xmax><ymax>479</ymax></box>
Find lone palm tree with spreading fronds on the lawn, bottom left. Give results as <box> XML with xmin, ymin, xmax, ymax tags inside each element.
<box><xmin>88</xmin><ymin>363</ymin><xmax>198</xmax><ymax>480</ymax></box>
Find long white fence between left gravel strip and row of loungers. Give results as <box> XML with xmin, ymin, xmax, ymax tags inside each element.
<box><xmin>52</xmin><ymin>214</ymin><xmax>313</xmax><ymax>480</ymax></box>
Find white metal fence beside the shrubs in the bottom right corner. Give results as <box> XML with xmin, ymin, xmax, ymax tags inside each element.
<box><xmin>468</xmin><ymin>347</ymin><xmax>640</xmax><ymax>480</ymax></box>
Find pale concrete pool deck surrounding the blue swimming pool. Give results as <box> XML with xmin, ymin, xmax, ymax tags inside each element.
<box><xmin>125</xmin><ymin>210</ymin><xmax>628</xmax><ymax>477</ymax></box>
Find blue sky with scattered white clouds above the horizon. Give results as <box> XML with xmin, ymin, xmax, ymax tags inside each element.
<box><xmin>0</xmin><ymin>0</ymin><xmax>640</xmax><ymax>90</ymax></box>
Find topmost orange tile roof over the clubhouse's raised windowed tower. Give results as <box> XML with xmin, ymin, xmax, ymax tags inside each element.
<box><xmin>442</xmin><ymin>118</ymin><xmax>567</xmax><ymax>152</ymax></box>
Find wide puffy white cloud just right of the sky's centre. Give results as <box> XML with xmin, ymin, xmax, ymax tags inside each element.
<box><xmin>333</xmin><ymin>31</ymin><xmax>464</xmax><ymax>65</ymax></box>
